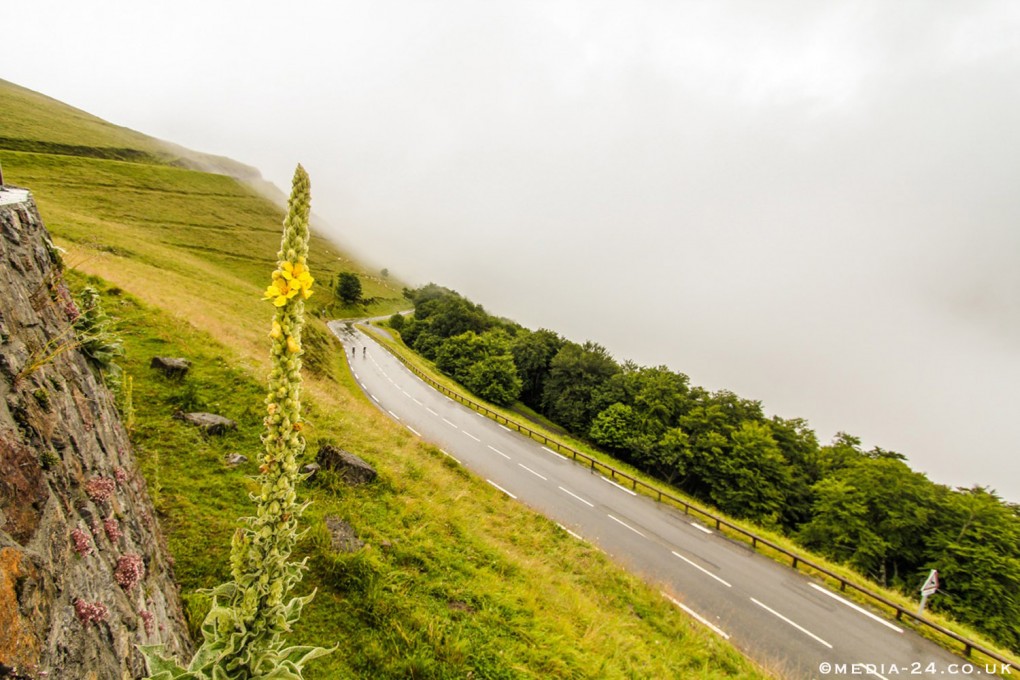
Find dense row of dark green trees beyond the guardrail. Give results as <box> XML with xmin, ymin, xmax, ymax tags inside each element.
<box><xmin>390</xmin><ymin>283</ymin><xmax>1020</xmax><ymax>651</ymax></box>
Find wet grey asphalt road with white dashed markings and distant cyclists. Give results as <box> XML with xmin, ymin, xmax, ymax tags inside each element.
<box><xmin>330</xmin><ymin>322</ymin><xmax>984</xmax><ymax>678</ymax></box>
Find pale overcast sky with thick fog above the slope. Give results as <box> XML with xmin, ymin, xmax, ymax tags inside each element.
<box><xmin>7</xmin><ymin>0</ymin><xmax>1020</xmax><ymax>501</ymax></box>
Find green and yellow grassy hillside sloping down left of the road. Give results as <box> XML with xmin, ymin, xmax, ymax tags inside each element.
<box><xmin>0</xmin><ymin>82</ymin><xmax>766</xmax><ymax>679</ymax></box>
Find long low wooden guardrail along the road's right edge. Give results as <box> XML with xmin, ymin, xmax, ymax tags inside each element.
<box><xmin>357</xmin><ymin>326</ymin><xmax>1020</xmax><ymax>672</ymax></box>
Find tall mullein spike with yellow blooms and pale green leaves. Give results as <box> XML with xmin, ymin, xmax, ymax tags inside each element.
<box><xmin>143</xmin><ymin>165</ymin><xmax>333</xmax><ymax>680</ymax></box>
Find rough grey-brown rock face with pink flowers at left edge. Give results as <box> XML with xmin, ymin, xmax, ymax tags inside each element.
<box><xmin>0</xmin><ymin>192</ymin><xmax>191</xmax><ymax>680</ymax></box>
